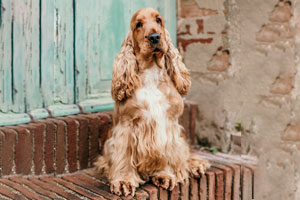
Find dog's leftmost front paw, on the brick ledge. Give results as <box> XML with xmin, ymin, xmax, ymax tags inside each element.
<box><xmin>110</xmin><ymin>181</ymin><xmax>136</xmax><ymax>196</ymax></box>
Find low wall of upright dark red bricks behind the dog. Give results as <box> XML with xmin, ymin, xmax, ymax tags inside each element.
<box><xmin>0</xmin><ymin>102</ymin><xmax>197</xmax><ymax>177</ymax></box>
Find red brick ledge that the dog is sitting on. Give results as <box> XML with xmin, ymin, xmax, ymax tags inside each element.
<box><xmin>0</xmin><ymin>151</ymin><xmax>257</xmax><ymax>200</ymax></box>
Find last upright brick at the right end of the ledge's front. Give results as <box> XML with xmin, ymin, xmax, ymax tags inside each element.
<box><xmin>242</xmin><ymin>167</ymin><xmax>252</xmax><ymax>200</ymax></box>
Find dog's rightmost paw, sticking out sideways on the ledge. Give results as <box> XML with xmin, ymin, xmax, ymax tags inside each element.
<box><xmin>188</xmin><ymin>158</ymin><xmax>210</xmax><ymax>178</ymax></box>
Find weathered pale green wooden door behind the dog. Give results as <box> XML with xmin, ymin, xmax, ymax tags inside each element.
<box><xmin>0</xmin><ymin>0</ymin><xmax>176</xmax><ymax>125</ymax></box>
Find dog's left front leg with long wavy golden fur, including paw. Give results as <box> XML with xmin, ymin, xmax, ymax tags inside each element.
<box><xmin>95</xmin><ymin>124</ymin><xmax>144</xmax><ymax>196</ymax></box>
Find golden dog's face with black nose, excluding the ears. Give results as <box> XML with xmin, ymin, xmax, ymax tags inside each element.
<box><xmin>130</xmin><ymin>8</ymin><xmax>168</xmax><ymax>57</ymax></box>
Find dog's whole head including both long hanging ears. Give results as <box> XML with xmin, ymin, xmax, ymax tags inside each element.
<box><xmin>111</xmin><ymin>8</ymin><xmax>191</xmax><ymax>102</ymax></box>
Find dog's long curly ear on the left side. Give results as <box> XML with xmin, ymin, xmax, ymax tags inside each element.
<box><xmin>111</xmin><ymin>31</ymin><xmax>141</xmax><ymax>102</ymax></box>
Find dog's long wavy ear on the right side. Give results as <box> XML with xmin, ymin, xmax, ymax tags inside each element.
<box><xmin>165</xmin><ymin>29</ymin><xmax>191</xmax><ymax>95</ymax></box>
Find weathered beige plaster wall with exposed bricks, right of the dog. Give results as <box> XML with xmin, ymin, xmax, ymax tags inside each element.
<box><xmin>177</xmin><ymin>0</ymin><xmax>300</xmax><ymax>199</ymax></box>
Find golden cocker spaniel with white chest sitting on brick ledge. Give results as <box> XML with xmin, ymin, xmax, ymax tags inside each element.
<box><xmin>95</xmin><ymin>8</ymin><xmax>209</xmax><ymax>196</ymax></box>
